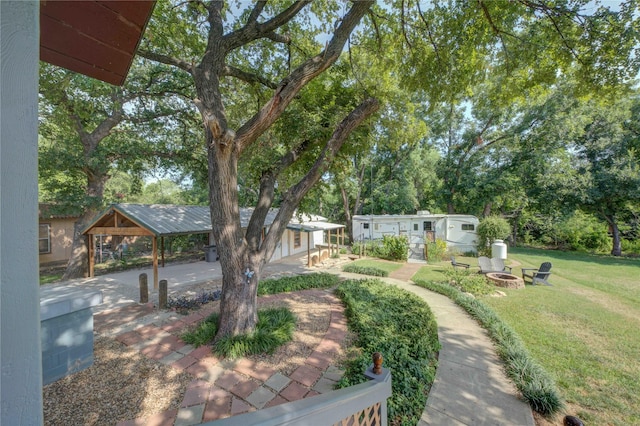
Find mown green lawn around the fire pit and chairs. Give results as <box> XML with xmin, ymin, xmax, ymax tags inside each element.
<box><xmin>420</xmin><ymin>249</ymin><xmax>640</xmax><ymax>425</ymax></box>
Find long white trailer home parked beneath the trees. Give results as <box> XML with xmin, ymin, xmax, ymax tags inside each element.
<box><xmin>353</xmin><ymin>210</ymin><xmax>479</xmax><ymax>259</ymax></box>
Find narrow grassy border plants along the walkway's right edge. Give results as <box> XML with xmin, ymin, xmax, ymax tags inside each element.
<box><xmin>416</xmin><ymin>280</ymin><xmax>564</xmax><ymax>415</ymax></box>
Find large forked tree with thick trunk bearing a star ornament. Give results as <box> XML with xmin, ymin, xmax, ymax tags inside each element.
<box><xmin>139</xmin><ymin>1</ymin><xmax>378</xmax><ymax>338</ymax></box>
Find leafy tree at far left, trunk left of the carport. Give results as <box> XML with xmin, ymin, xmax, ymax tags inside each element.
<box><xmin>39</xmin><ymin>62</ymin><xmax>197</xmax><ymax>279</ymax></box>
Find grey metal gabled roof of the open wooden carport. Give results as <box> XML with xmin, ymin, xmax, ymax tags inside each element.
<box><xmin>82</xmin><ymin>204</ymin><xmax>278</xmax><ymax>237</ymax></box>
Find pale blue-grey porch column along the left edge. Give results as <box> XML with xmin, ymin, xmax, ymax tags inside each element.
<box><xmin>0</xmin><ymin>0</ymin><xmax>43</xmax><ymax>425</ymax></box>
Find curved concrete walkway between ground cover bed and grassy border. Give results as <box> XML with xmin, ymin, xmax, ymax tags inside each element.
<box><xmin>385</xmin><ymin>263</ymin><xmax>535</xmax><ymax>426</ymax></box>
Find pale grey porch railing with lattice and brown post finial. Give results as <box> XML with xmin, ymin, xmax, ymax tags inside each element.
<box><xmin>204</xmin><ymin>352</ymin><xmax>391</xmax><ymax>426</ymax></box>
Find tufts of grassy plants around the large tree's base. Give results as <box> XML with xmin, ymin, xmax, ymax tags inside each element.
<box><xmin>182</xmin><ymin>308</ymin><xmax>296</xmax><ymax>359</ymax></box>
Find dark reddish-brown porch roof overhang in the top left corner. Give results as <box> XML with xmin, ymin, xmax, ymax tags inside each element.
<box><xmin>40</xmin><ymin>0</ymin><xmax>156</xmax><ymax>86</ymax></box>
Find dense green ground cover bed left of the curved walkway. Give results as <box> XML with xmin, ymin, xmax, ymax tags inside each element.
<box><xmin>336</xmin><ymin>280</ymin><xmax>440</xmax><ymax>425</ymax></box>
